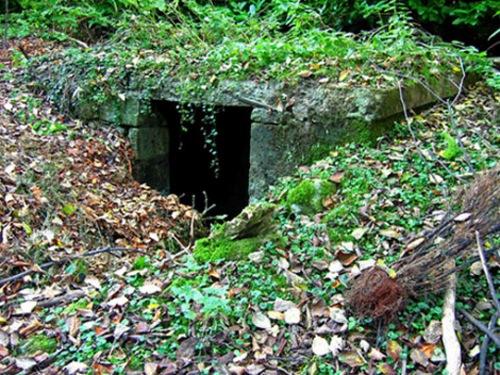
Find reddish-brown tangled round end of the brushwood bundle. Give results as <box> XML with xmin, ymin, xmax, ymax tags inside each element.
<box><xmin>347</xmin><ymin>267</ymin><xmax>407</xmax><ymax>322</ymax></box>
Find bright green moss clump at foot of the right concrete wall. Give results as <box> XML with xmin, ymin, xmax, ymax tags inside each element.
<box><xmin>285</xmin><ymin>179</ymin><xmax>335</xmax><ymax>213</ymax></box>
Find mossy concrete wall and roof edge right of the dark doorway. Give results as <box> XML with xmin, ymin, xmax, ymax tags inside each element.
<box><xmin>249</xmin><ymin>81</ymin><xmax>457</xmax><ymax>197</ymax></box>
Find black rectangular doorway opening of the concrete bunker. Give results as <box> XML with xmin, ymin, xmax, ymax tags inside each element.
<box><xmin>154</xmin><ymin>101</ymin><xmax>252</xmax><ymax>218</ymax></box>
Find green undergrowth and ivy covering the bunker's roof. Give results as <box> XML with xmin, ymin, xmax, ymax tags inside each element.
<box><xmin>21</xmin><ymin>1</ymin><xmax>490</xmax><ymax>117</ymax></box>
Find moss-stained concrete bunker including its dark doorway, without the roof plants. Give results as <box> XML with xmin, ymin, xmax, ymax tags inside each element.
<box><xmin>69</xmin><ymin>77</ymin><xmax>459</xmax><ymax>217</ymax></box>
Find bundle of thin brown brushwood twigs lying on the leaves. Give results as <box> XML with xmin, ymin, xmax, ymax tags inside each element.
<box><xmin>347</xmin><ymin>168</ymin><xmax>500</xmax><ymax>321</ymax></box>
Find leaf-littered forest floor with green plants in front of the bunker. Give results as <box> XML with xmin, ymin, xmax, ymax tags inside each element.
<box><xmin>0</xmin><ymin>40</ymin><xmax>500</xmax><ymax>374</ymax></box>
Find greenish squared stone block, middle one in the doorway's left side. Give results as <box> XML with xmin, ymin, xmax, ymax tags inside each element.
<box><xmin>128</xmin><ymin>127</ymin><xmax>169</xmax><ymax>160</ymax></box>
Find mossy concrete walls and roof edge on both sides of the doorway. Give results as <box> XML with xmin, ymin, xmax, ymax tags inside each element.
<box><xmin>58</xmin><ymin>76</ymin><xmax>457</xmax><ymax>198</ymax></box>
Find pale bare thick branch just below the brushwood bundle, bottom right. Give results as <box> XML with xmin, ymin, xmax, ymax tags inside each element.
<box><xmin>441</xmin><ymin>270</ymin><xmax>462</xmax><ymax>375</ymax></box>
